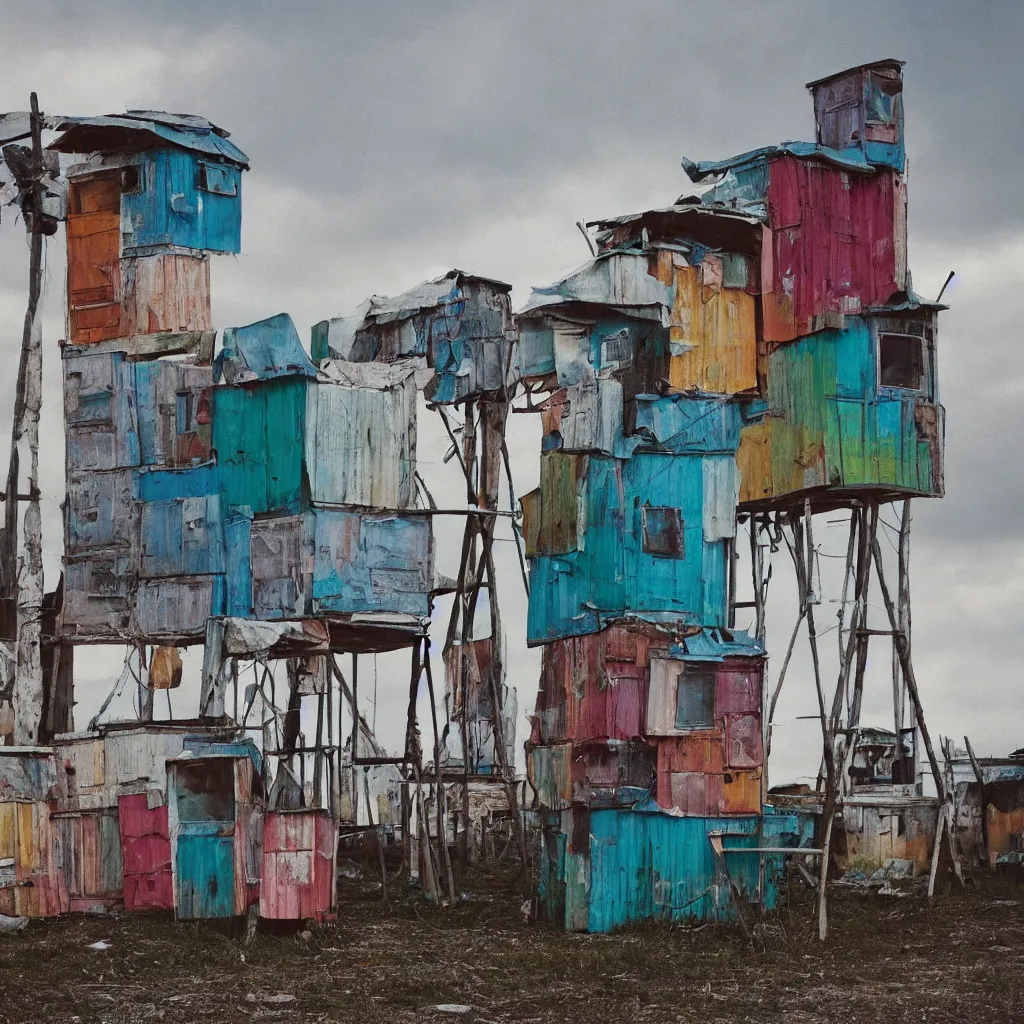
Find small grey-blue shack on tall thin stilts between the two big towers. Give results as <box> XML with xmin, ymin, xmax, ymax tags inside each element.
<box><xmin>312</xmin><ymin>270</ymin><xmax>521</xmax><ymax>876</ymax></box>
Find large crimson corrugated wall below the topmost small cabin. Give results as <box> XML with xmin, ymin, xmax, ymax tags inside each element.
<box><xmin>761</xmin><ymin>156</ymin><xmax>906</xmax><ymax>342</ymax></box>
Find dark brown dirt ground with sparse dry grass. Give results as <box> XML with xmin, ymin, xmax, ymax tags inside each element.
<box><xmin>0</xmin><ymin>874</ymin><xmax>1024</xmax><ymax>1024</ymax></box>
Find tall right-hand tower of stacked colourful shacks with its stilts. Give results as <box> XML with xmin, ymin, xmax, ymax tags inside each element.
<box><xmin>519</xmin><ymin>60</ymin><xmax>942</xmax><ymax>931</ymax></box>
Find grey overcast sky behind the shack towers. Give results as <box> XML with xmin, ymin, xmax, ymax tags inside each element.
<box><xmin>0</xmin><ymin>0</ymin><xmax>1024</xmax><ymax>781</ymax></box>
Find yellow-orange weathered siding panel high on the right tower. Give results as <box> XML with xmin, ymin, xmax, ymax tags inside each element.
<box><xmin>654</xmin><ymin>250</ymin><xmax>758</xmax><ymax>394</ymax></box>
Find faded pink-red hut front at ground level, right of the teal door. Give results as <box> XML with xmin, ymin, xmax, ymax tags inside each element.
<box><xmin>259</xmin><ymin>810</ymin><xmax>338</xmax><ymax>921</ymax></box>
